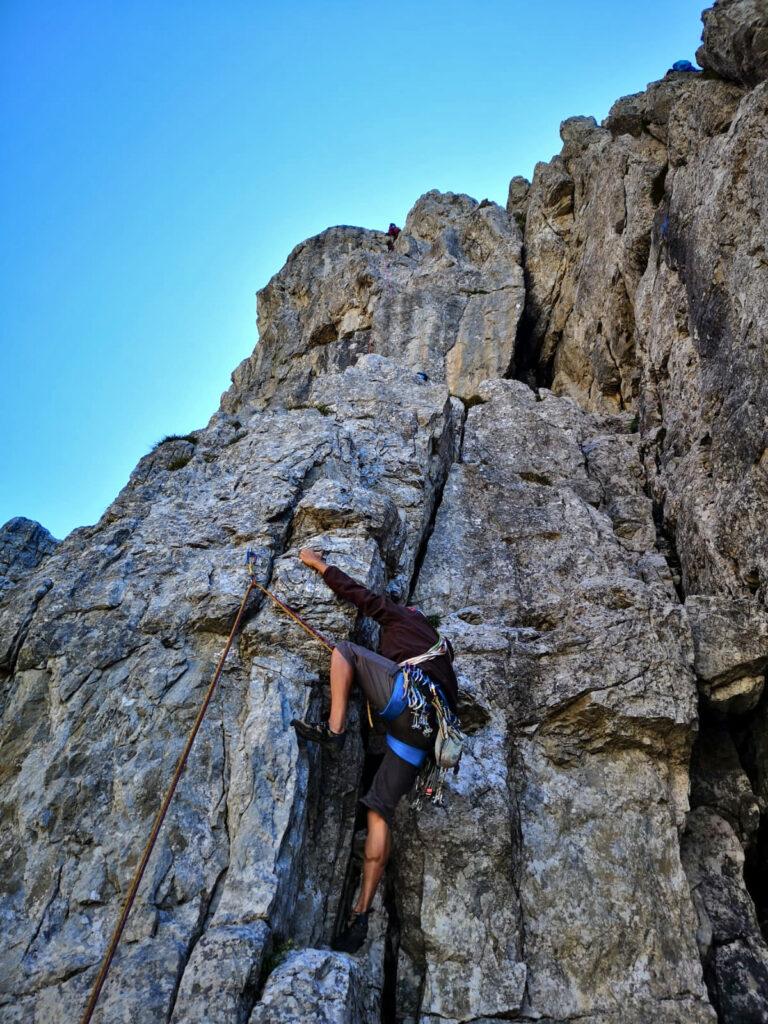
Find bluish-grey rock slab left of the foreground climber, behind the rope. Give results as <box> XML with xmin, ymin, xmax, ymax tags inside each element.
<box><xmin>0</xmin><ymin>355</ymin><xmax>462</xmax><ymax>1021</ymax></box>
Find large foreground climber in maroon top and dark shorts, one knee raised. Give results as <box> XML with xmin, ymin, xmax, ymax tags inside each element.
<box><xmin>291</xmin><ymin>548</ymin><xmax>459</xmax><ymax>952</ymax></box>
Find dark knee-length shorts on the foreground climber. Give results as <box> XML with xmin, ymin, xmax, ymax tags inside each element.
<box><xmin>336</xmin><ymin>640</ymin><xmax>434</xmax><ymax>827</ymax></box>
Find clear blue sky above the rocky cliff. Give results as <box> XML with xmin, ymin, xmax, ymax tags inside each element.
<box><xmin>0</xmin><ymin>0</ymin><xmax>705</xmax><ymax>537</ymax></box>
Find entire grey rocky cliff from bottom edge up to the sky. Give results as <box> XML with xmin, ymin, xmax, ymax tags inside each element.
<box><xmin>0</xmin><ymin>0</ymin><xmax>768</xmax><ymax>1024</ymax></box>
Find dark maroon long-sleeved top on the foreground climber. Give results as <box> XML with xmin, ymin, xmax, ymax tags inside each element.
<box><xmin>323</xmin><ymin>565</ymin><xmax>459</xmax><ymax>711</ymax></box>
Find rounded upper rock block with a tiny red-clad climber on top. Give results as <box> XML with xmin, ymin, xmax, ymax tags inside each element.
<box><xmin>223</xmin><ymin>191</ymin><xmax>524</xmax><ymax>412</ymax></box>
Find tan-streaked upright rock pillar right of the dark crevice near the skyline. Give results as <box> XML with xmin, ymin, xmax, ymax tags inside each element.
<box><xmin>518</xmin><ymin>118</ymin><xmax>667</xmax><ymax>411</ymax></box>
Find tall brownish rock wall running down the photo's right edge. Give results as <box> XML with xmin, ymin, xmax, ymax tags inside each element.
<box><xmin>518</xmin><ymin>0</ymin><xmax>768</xmax><ymax>1022</ymax></box>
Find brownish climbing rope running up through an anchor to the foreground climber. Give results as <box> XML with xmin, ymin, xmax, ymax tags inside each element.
<box><xmin>81</xmin><ymin>548</ymin><xmax>333</xmax><ymax>1024</ymax></box>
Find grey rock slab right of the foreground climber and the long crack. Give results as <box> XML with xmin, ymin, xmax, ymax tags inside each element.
<box><xmin>397</xmin><ymin>380</ymin><xmax>711</xmax><ymax>1022</ymax></box>
